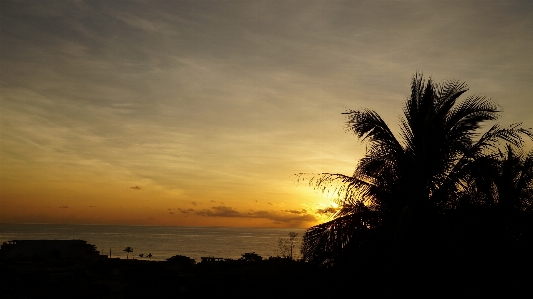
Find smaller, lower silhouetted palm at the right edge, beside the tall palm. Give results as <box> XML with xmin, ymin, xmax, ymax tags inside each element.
<box><xmin>449</xmin><ymin>144</ymin><xmax>533</xmax><ymax>264</ymax></box>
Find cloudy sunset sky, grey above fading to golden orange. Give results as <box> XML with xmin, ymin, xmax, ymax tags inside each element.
<box><xmin>0</xmin><ymin>0</ymin><xmax>533</xmax><ymax>228</ymax></box>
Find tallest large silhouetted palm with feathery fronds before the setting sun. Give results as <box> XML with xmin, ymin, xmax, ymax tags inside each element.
<box><xmin>300</xmin><ymin>74</ymin><xmax>533</xmax><ymax>265</ymax></box>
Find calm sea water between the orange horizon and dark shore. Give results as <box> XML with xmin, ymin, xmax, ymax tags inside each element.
<box><xmin>0</xmin><ymin>224</ymin><xmax>305</xmax><ymax>262</ymax></box>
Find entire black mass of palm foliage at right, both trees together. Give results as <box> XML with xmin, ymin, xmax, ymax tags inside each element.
<box><xmin>299</xmin><ymin>74</ymin><xmax>533</xmax><ymax>266</ymax></box>
